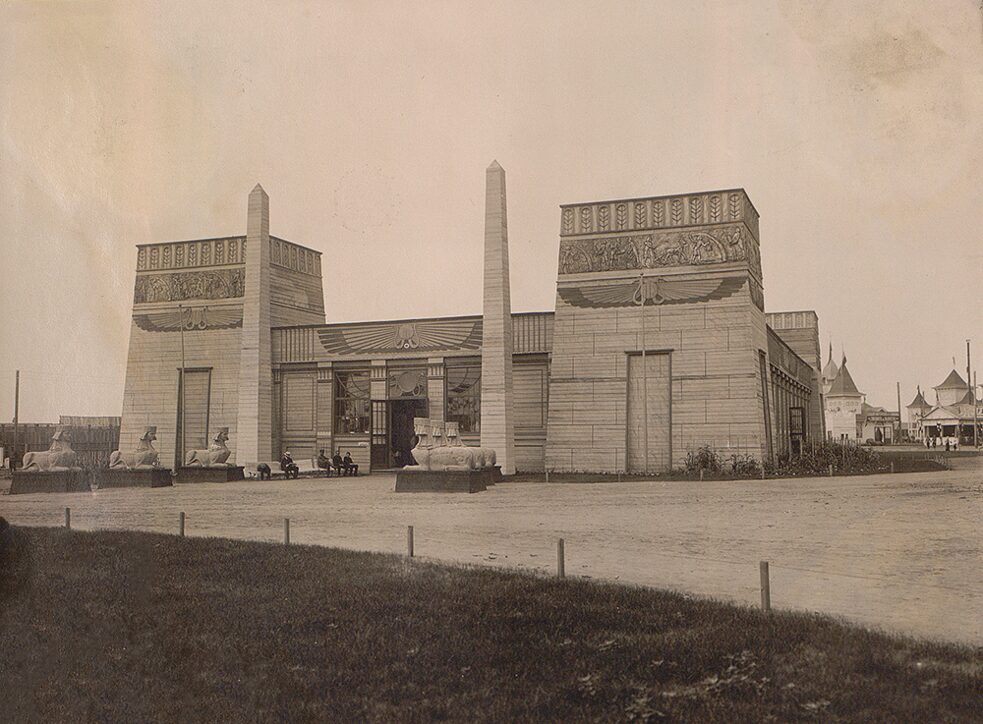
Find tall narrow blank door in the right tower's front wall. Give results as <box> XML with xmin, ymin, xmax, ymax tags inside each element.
<box><xmin>627</xmin><ymin>352</ymin><xmax>672</xmax><ymax>473</ymax></box>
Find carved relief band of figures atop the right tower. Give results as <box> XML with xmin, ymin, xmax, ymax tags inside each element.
<box><xmin>559</xmin><ymin>224</ymin><xmax>761</xmax><ymax>278</ymax></box>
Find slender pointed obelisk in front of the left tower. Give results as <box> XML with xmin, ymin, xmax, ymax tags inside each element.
<box><xmin>230</xmin><ymin>184</ymin><xmax>273</xmax><ymax>469</ymax></box>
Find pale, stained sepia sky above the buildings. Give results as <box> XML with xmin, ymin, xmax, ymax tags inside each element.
<box><xmin>0</xmin><ymin>0</ymin><xmax>983</xmax><ymax>421</ymax></box>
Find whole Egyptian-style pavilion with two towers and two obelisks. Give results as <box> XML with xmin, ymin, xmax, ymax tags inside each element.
<box><xmin>120</xmin><ymin>163</ymin><xmax>825</xmax><ymax>475</ymax></box>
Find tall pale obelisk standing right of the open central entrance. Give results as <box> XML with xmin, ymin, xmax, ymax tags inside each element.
<box><xmin>481</xmin><ymin>161</ymin><xmax>515</xmax><ymax>475</ymax></box>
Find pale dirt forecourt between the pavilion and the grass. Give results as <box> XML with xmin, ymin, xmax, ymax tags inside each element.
<box><xmin>0</xmin><ymin>457</ymin><xmax>983</xmax><ymax>645</ymax></box>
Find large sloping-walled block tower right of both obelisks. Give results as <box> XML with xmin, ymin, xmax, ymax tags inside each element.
<box><xmin>545</xmin><ymin>189</ymin><xmax>770</xmax><ymax>472</ymax></box>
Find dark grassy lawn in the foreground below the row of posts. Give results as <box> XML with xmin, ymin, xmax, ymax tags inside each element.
<box><xmin>0</xmin><ymin>528</ymin><xmax>983</xmax><ymax>722</ymax></box>
